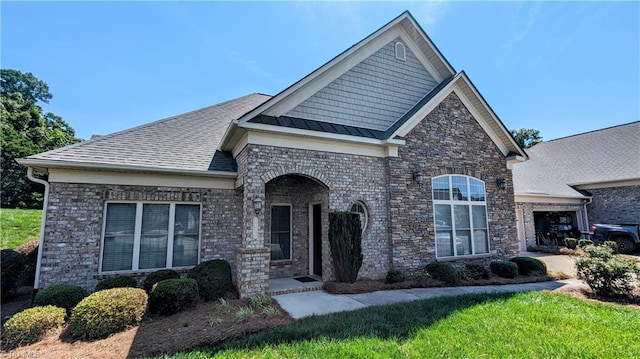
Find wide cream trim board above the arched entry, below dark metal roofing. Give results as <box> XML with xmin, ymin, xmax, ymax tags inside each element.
<box><xmin>247</xmin><ymin>131</ymin><xmax>398</xmax><ymax>158</ymax></box>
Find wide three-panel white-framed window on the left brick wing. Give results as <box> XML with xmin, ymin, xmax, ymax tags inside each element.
<box><xmin>100</xmin><ymin>202</ymin><xmax>200</xmax><ymax>272</ymax></box>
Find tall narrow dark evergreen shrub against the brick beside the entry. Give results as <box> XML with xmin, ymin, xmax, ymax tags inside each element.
<box><xmin>329</xmin><ymin>212</ymin><xmax>363</xmax><ymax>283</ymax></box>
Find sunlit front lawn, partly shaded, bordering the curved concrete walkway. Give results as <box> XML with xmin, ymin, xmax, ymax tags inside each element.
<box><xmin>159</xmin><ymin>292</ymin><xmax>640</xmax><ymax>359</ymax></box>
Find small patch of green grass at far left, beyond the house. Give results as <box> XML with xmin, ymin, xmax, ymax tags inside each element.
<box><xmin>0</xmin><ymin>208</ymin><xmax>42</xmax><ymax>249</ymax></box>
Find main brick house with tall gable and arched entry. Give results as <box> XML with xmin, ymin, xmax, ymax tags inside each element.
<box><xmin>20</xmin><ymin>12</ymin><xmax>526</xmax><ymax>297</ymax></box>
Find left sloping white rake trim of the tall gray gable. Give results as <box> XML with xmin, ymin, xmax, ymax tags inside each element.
<box><xmin>238</xmin><ymin>14</ymin><xmax>410</xmax><ymax>124</ymax></box>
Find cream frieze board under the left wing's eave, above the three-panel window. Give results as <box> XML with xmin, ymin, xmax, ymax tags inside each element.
<box><xmin>49</xmin><ymin>168</ymin><xmax>235</xmax><ymax>189</ymax></box>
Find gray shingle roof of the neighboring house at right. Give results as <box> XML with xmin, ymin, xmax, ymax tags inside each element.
<box><xmin>513</xmin><ymin>121</ymin><xmax>640</xmax><ymax>197</ymax></box>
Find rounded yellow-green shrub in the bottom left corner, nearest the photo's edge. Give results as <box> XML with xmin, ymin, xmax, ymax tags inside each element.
<box><xmin>2</xmin><ymin>305</ymin><xmax>66</xmax><ymax>350</ymax></box>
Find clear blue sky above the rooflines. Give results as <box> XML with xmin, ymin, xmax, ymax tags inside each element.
<box><xmin>0</xmin><ymin>1</ymin><xmax>640</xmax><ymax>140</ymax></box>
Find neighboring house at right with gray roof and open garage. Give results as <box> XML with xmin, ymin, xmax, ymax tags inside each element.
<box><xmin>513</xmin><ymin>122</ymin><xmax>640</xmax><ymax>249</ymax></box>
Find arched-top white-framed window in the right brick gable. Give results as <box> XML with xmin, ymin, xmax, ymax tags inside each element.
<box><xmin>431</xmin><ymin>175</ymin><xmax>489</xmax><ymax>258</ymax></box>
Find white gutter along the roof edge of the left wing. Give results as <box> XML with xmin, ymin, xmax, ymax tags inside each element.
<box><xmin>17</xmin><ymin>158</ymin><xmax>238</xmax><ymax>178</ymax></box>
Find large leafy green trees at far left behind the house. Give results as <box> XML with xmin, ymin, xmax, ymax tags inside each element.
<box><xmin>0</xmin><ymin>69</ymin><xmax>79</xmax><ymax>208</ymax></box>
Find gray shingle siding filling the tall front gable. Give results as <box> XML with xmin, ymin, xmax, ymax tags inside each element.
<box><xmin>286</xmin><ymin>38</ymin><xmax>437</xmax><ymax>131</ymax></box>
